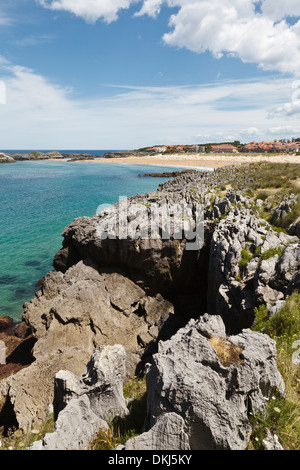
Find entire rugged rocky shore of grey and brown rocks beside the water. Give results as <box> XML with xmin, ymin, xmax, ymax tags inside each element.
<box><xmin>0</xmin><ymin>166</ymin><xmax>300</xmax><ymax>450</ymax></box>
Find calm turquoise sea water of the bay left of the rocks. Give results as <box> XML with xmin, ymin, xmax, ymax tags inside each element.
<box><xmin>0</xmin><ymin>161</ymin><xmax>202</xmax><ymax>320</ymax></box>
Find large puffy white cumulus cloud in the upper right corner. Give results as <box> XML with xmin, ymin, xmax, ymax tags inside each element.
<box><xmin>164</xmin><ymin>0</ymin><xmax>300</xmax><ymax>75</ymax></box>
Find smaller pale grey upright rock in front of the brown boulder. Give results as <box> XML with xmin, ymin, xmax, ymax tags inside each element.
<box><xmin>30</xmin><ymin>345</ymin><xmax>128</xmax><ymax>450</ymax></box>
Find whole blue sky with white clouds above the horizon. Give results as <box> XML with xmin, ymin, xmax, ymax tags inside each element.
<box><xmin>0</xmin><ymin>0</ymin><xmax>300</xmax><ymax>150</ymax></box>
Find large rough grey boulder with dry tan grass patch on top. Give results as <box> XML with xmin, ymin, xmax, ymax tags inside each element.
<box><xmin>144</xmin><ymin>317</ymin><xmax>284</xmax><ymax>450</ymax></box>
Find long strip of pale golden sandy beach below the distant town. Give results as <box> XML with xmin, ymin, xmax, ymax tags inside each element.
<box><xmin>75</xmin><ymin>154</ymin><xmax>300</xmax><ymax>168</ymax></box>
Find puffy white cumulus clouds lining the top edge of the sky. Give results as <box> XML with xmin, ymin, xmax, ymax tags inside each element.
<box><xmin>37</xmin><ymin>0</ymin><xmax>300</xmax><ymax>75</ymax></box>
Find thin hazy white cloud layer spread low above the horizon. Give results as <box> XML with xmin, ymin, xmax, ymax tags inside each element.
<box><xmin>0</xmin><ymin>58</ymin><xmax>298</xmax><ymax>149</ymax></box>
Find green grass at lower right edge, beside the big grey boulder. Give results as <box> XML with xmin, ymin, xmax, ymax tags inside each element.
<box><xmin>249</xmin><ymin>292</ymin><xmax>300</xmax><ymax>450</ymax></box>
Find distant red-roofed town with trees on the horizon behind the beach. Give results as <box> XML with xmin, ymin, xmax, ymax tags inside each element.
<box><xmin>140</xmin><ymin>138</ymin><xmax>300</xmax><ymax>153</ymax></box>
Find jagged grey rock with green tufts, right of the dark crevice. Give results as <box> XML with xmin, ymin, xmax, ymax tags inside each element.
<box><xmin>208</xmin><ymin>209</ymin><xmax>300</xmax><ymax>333</ymax></box>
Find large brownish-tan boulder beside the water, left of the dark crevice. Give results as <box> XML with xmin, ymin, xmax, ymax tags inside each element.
<box><xmin>0</xmin><ymin>261</ymin><xmax>176</xmax><ymax>429</ymax></box>
